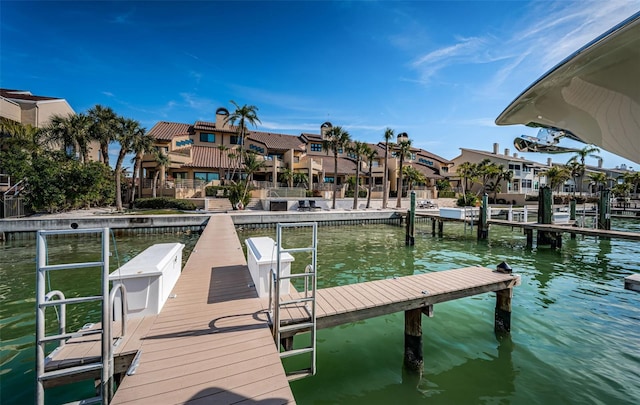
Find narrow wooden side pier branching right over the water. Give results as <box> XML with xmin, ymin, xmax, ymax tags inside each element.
<box><xmin>263</xmin><ymin>267</ymin><xmax>520</xmax><ymax>329</ymax></box>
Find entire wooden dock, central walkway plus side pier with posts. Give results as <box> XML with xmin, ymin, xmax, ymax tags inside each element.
<box><xmin>48</xmin><ymin>214</ymin><xmax>520</xmax><ymax>405</ymax></box>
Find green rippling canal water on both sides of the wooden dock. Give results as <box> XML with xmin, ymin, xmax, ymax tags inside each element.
<box><xmin>0</xmin><ymin>221</ymin><xmax>640</xmax><ymax>405</ymax></box>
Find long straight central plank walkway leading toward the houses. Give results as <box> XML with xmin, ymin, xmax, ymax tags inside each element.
<box><xmin>112</xmin><ymin>214</ymin><xmax>295</xmax><ymax>405</ymax></box>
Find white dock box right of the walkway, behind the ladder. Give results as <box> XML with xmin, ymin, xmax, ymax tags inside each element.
<box><xmin>245</xmin><ymin>236</ymin><xmax>295</xmax><ymax>297</ymax></box>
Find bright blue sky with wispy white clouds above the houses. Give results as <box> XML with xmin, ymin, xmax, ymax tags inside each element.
<box><xmin>0</xmin><ymin>0</ymin><xmax>640</xmax><ymax>170</ymax></box>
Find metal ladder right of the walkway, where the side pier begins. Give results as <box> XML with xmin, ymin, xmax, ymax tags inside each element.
<box><xmin>269</xmin><ymin>222</ymin><xmax>318</xmax><ymax>381</ymax></box>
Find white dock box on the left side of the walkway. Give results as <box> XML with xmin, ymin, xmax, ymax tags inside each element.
<box><xmin>109</xmin><ymin>243</ymin><xmax>184</xmax><ymax>317</ymax></box>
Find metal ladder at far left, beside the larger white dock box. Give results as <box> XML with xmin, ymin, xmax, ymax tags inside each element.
<box><xmin>36</xmin><ymin>228</ymin><xmax>113</xmax><ymax>405</ymax></box>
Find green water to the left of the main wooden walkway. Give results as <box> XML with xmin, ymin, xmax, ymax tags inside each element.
<box><xmin>0</xmin><ymin>234</ymin><xmax>197</xmax><ymax>405</ymax></box>
